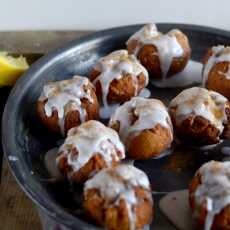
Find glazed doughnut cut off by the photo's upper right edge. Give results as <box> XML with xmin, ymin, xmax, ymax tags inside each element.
<box><xmin>203</xmin><ymin>45</ymin><xmax>230</xmax><ymax>99</ymax></box>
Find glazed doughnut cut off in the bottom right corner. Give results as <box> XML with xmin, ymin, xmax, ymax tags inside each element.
<box><xmin>189</xmin><ymin>161</ymin><xmax>230</xmax><ymax>230</ymax></box>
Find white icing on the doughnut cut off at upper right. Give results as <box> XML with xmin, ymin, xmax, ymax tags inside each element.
<box><xmin>203</xmin><ymin>45</ymin><xmax>230</xmax><ymax>85</ymax></box>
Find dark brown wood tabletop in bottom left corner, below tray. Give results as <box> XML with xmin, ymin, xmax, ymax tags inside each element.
<box><xmin>0</xmin><ymin>160</ymin><xmax>42</xmax><ymax>230</ymax></box>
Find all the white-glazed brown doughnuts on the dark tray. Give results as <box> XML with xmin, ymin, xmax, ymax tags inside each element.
<box><xmin>37</xmin><ymin>24</ymin><xmax>230</xmax><ymax>230</ymax></box>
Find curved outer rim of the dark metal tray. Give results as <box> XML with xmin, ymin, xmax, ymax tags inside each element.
<box><xmin>2</xmin><ymin>23</ymin><xmax>230</xmax><ymax>230</ymax></box>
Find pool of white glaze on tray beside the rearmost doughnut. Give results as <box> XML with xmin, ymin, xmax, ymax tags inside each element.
<box><xmin>151</xmin><ymin>60</ymin><xmax>202</xmax><ymax>88</ymax></box>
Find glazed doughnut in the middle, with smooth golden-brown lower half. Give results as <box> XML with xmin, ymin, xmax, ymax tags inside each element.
<box><xmin>109</xmin><ymin>97</ymin><xmax>173</xmax><ymax>159</ymax></box>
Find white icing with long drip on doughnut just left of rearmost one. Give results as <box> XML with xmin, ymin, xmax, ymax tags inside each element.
<box><xmin>93</xmin><ymin>50</ymin><xmax>149</xmax><ymax>118</ymax></box>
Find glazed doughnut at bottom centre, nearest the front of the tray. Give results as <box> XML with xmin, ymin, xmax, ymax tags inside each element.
<box><xmin>84</xmin><ymin>165</ymin><xmax>153</xmax><ymax>230</ymax></box>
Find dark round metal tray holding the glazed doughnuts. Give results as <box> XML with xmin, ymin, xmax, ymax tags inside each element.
<box><xmin>2</xmin><ymin>24</ymin><xmax>230</xmax><ymax>230</ymax></box>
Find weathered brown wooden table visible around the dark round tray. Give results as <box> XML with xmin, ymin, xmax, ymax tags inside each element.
<box><xmin>0</xmin><ymin>31</ymin><xmax>89</xmax><ymax>230</ymax></box>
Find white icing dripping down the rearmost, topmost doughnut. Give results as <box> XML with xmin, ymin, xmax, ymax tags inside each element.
<box><xmin>127</xmin><ymin>24</ymin><xmax>184</xmax><ymax>78</ymax></box>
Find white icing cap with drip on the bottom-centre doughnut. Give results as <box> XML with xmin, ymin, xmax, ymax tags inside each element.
<box><xmin>84</xmin><ymin>165</ymin><xmax>151</xmax><ymax>230</ymax></box>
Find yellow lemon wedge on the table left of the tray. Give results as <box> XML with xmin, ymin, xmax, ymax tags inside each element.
<box><xmin>0</xmin><ymin>52</ymin><xmax>29</xmax><ymax>86</ymax></box>
